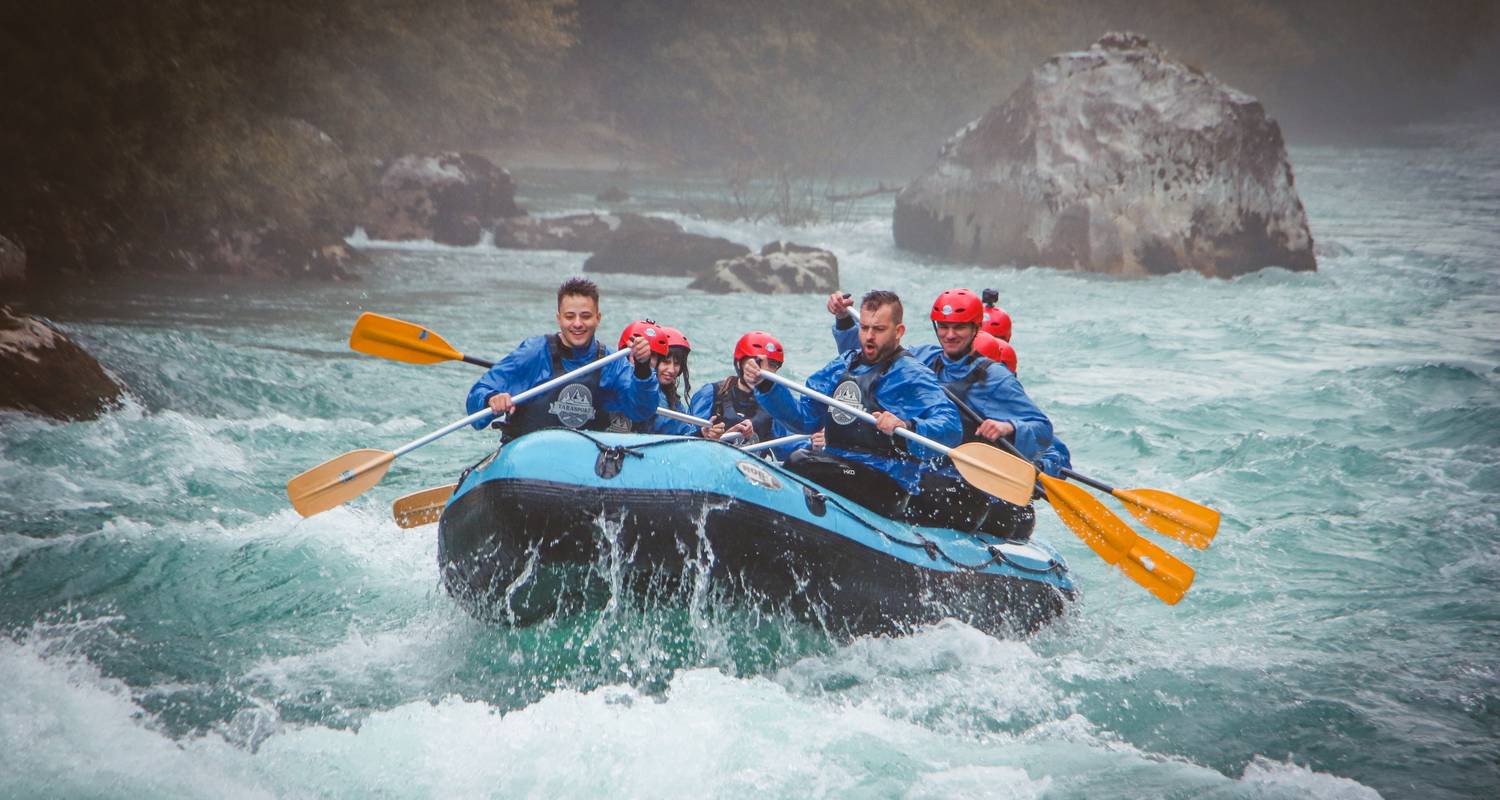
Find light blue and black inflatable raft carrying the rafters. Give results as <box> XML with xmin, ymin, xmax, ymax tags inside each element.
<box><xmin>438</xmin><ymin>429</ymin><xmax>1076</xmax><ymax>635</ymax></box>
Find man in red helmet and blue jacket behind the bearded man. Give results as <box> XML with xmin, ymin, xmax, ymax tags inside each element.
<box><xmin>828</xmin><ymin>288</ymin><xmax>1053</xmax><ymax>539</ymax></box>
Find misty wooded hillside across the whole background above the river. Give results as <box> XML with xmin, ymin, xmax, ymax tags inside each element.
<box><xmin>0</xmin><ymin>0</ymin><xmax>1500</xmax><ymax>275</ymax></box>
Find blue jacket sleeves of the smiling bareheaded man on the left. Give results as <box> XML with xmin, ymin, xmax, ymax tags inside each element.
<box><xmin>465</xmin><ymin>336</ymin><xmax>662</xmax><ymax>429</ymax></box>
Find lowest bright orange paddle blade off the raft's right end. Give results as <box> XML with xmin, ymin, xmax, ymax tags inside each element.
<box><xmin>1040</xmin><ymin>474</ymin><xmax>1194</xmax><ymax>605</ymax></box>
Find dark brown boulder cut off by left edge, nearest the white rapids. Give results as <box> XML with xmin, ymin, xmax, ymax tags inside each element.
<box><xmin>0</xmin><ymin>306</ymin><xmax>122</xmax><ymax>419</ymax></box>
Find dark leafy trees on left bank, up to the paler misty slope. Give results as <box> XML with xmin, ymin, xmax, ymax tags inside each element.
<box><xmin>0</xmin><ymin>0</ymin><xmax>573</xmax><ymax>273</ymax></box>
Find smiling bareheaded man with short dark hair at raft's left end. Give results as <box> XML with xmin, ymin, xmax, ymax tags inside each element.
<box><xmin>465</xmin><ymin>278</ymin><xmax>659</xmax><ymax>440</ymax></box>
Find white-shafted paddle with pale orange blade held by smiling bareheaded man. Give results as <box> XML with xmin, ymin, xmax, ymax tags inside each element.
<box><xmin>287</xmin><ymin>350</ymin><xmax>630</xmax><ymax>516</ymax></box>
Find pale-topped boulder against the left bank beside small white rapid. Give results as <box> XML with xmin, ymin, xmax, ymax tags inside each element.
<box><xmin>362</xmin><ymin>153</ymin><xmax>525</xmax><ymax>246</ymax></box>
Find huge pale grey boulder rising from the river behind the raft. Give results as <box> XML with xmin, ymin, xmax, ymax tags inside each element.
<box><xmin>893</xmin><ymin>33</ymin><xmax>1317</xmax><ymax>278</ymax></box>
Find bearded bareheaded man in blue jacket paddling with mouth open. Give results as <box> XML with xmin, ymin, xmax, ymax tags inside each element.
<box><xmin>744</xmin><ymin>291</ymin><xmax>963</xmax><ymax>515</ymax></box>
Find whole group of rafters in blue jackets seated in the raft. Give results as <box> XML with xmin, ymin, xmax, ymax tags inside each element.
<box><xmin>468</xmin><ymin>278</ymin><xmax>1071</xmax><ymax>539</ymax></box>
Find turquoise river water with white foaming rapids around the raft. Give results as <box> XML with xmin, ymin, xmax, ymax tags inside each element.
<box><xmin>0</xmin><ymin>121</ymin><xmax>1500</xmax><ymax>797</ymax></box>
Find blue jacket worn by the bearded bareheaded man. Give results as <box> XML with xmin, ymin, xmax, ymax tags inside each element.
<box><xmin>756</xmin><ymin>353</ymin><xmax>963</xmax><ymax>492</ymax></box>
